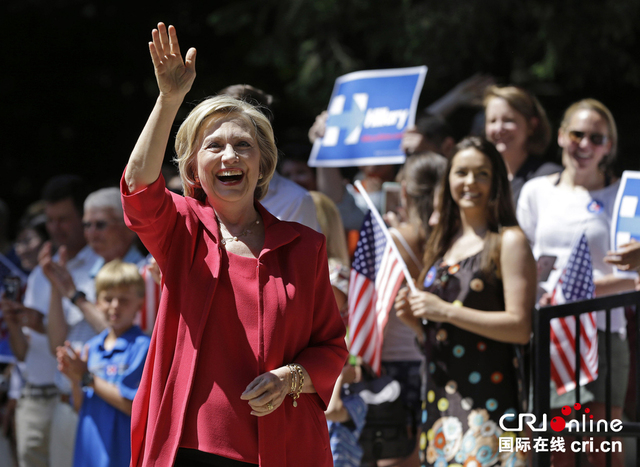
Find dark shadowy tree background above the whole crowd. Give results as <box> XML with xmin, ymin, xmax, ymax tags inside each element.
<box><xmin>0</xmin><ymin>0</ymin><xmax>640</xmax><ymax>231</ymax></box>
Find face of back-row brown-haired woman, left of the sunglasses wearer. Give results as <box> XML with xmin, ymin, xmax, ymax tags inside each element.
<box><xmin>485</xmin><ymin>97</ymin><xmax>531</xmax><ymax>157</ymax></box>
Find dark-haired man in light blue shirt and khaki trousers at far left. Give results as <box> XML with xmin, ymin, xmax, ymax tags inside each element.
<box><xmin>2</xmin><ymin>175</ymin><xmax>104</xmax><ymax>467</ymax></box>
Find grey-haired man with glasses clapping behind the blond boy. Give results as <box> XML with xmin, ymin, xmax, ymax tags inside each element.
<box><xmin>40</xmin><ymin>183</ymin><xmax>144</xmax><ymax>467</ymax></box>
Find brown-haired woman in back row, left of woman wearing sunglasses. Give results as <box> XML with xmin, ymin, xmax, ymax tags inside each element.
<box><xmin>484</xmin><ymin>86</ymin><xmax>561</xmax><ymax>204</ymax></box>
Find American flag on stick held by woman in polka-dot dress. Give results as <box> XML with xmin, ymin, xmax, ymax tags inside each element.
<box><xmin>349</xmin><ymin>212</ymin><xmax>405</xmax><ymax>374</ymax></box>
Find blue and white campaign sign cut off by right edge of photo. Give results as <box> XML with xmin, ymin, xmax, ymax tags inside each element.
<box><xmin>611</xmin><ymin>170</ymin><xmax>640</xmax><ymax>275</ymax></box>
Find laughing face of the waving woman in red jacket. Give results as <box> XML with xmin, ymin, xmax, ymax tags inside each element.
<box><xmin>196</xmin><ymin>114</ymin><xmax>260</xmax><ymax>207</ymax></box>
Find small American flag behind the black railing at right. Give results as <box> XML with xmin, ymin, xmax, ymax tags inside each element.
<box><xmin>551</xmin><ymin>233</ymin><xmax>598</xmax><ymax>394</ymax></box>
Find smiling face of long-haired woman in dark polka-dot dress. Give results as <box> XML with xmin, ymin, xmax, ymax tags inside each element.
<box><xmin>449</xmin><ymin>148</ymin><xmax>493</xmax><ymax>210</ymax></box>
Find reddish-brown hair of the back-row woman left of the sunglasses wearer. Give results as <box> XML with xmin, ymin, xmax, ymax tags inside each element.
<box><xmin>483</xmin><ymin>86</ymin><xmax>551</xmax><ymax>156</ymax></box>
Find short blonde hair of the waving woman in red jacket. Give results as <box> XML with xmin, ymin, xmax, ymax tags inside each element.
<box><xmin>174</xmin><ymin>95</ymin><xmax>278</xmax><ymax>201</ymax></box>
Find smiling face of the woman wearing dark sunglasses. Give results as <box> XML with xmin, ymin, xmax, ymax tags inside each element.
<box><xmin>558</xmin><ymin>109</ymin><xmax>612</xmax><ymax>173</ymax></box>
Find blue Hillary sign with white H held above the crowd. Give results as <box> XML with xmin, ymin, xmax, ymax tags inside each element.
<box><xmin>309</xmin><ymin>66</ymin><xmax>427</xmax><ymax>167</ymax></box>
